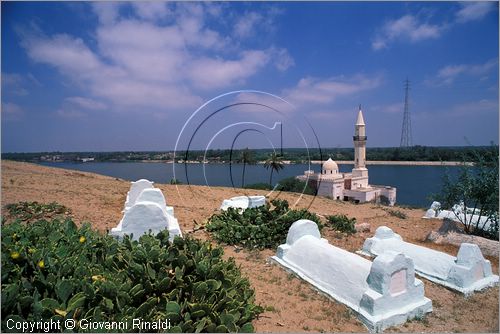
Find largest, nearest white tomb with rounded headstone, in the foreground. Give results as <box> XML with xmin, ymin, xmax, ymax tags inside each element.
<box><xmin>271</xmin><ymin>219</ymin><xmax>432</xmax><ymax>332</ymax></box>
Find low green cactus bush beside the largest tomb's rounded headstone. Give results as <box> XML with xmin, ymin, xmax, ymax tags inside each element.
<box><xmin>206</xmin><ymin>199</ymin><xmax>321</xmax><ymax>249</ymax></box>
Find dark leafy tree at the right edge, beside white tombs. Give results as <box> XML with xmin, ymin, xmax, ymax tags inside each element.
<box><xmin>436</xmin><ymin>145</ymin><xmax>499</xmax><ymax>239</ymax></box>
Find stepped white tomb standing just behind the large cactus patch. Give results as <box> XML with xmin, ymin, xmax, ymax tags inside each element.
<box><xmin>109</xmin><ymin>179</ymin><xmax>182</xmax><ymax>240</ymax></box>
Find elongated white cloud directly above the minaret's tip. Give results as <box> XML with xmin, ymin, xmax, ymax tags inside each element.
<box><xmin>284</xmin><ymin>75</ymin><xmax>382</xmax><ymax>105</ymax></box>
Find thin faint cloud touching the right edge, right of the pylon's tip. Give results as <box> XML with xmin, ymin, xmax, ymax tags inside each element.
<box><xmin>430</xmin><ymin>59</ymin><xmax>498</xmax><ymax>85</ymax></box>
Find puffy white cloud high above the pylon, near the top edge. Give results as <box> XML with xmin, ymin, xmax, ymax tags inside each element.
<box><xmin>372</xmin><ymin>15</ymin><xmax>445</xmax><ymax>50</ymax></box>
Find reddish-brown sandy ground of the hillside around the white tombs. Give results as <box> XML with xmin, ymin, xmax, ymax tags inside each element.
<box><xmin>1</xmin><ymin>161</ymin><xmax>499</xmax><ymax>332</ymax></box>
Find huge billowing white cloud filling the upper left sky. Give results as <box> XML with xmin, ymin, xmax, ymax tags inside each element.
<box><xmin>22</xmin><ymin>2</ymin><xmax>294</xmax><ymax>116</ymax></box>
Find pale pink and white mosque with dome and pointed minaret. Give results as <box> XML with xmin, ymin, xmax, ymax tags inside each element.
<box><xmin>297</xmin><ymin>106</ymin><xmax>396</xmax><ymax>206</ymax></box>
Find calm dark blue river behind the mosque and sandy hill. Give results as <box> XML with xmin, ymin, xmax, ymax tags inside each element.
<box><xmin>41</xmin><ymin>162</ymin><xmax>459</xmax><ymax>208</ymax></box>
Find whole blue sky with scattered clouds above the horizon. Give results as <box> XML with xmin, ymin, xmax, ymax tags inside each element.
<box><xmin>1</xmin><ymin>2</ymin><xmax>499</xmax><ymax>152</ymax></box>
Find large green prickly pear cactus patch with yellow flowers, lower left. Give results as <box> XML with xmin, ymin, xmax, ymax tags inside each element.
<box><xmin>1</xmin><ymin>219</ymin><xmax>262</xmax><ymax>332</ymax></box>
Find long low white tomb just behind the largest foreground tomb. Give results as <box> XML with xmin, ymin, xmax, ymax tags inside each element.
<box><xmin>360</xmin><ymin>226</ymin><xmax>498</xmax><ymax>295</ymax></box>
